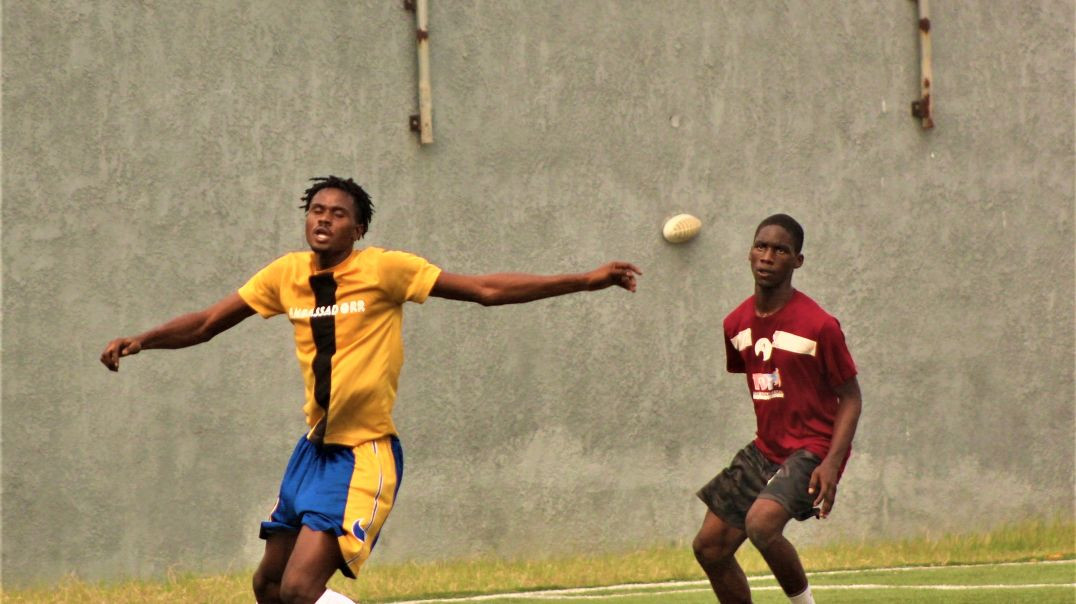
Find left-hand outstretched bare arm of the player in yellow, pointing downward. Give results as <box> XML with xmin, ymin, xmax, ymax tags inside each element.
<box><xmin>101</xmin><ymin>293</ymin><xmax>254</xmax><ymax>371</ymax></box>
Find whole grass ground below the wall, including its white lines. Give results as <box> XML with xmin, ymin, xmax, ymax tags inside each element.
<box><xmin>6</xmin><ymin>519</ymin><xmax>1076</xmax><ymax>604</ymax></box>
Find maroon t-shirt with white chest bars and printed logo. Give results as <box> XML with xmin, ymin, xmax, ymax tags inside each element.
<box><xmin>724</xmin><ymin>291</ymin><xmax>856</xmax><ymax>463</ymax></box>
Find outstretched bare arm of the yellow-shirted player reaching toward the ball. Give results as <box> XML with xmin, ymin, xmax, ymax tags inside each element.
<box><xmin>429</xmin><ymin>262</ymin><xmax>642</xmax><ymax>306</ymax></box>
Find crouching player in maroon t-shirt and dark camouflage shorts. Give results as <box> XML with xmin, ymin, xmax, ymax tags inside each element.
<box><xmin>693</xmin><ymin>214</ymin><xmax>863</xmax><ymax>604</ymax></box>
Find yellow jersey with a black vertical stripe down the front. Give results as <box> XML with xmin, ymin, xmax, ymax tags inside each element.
<box><xmin>239</xmin><ymin>248</ymin><xmax>441</xmax><ymax>447</ymax></box>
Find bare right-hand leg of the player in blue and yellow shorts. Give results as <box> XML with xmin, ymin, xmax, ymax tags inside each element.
<box><xmin>280</xmin><ymin>526</ymin><xmax>343</xmax><ymax>604</ymax></box>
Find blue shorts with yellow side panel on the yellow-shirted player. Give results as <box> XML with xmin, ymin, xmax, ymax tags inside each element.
<box><xmin>260</xmin><ymin>435</ymin><xmax>404</xmax><ymax>578</ymax></box>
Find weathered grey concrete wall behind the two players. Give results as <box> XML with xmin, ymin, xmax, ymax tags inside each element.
<box><xmin>0</xmin><ymin>0</ymin><xmax>1076</xmax><ymax>585</ymax></box>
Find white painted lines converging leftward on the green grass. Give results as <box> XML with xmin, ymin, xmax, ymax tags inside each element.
<box><xmin>394</xmin><ymin>560</ymin><xmax>1076</xmax><ymax>604</ymax></box>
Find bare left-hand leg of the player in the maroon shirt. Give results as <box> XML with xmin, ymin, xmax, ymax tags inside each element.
<box><xmin>692</xmin><ymin>510</ymin><xmax>751</xmax><ymax>604</ymax></box>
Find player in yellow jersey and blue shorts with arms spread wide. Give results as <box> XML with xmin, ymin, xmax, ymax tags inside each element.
<box><xmin>101</xmin><ymin>175</ymin><xmax>641</xmax><ymax>604</ymax></box>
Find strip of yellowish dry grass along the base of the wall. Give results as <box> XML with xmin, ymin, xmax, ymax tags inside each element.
<box><xmin>0</xmin><ymin>512</ymin><xmax>1076</xmax><ymax>604</ymax></box>
